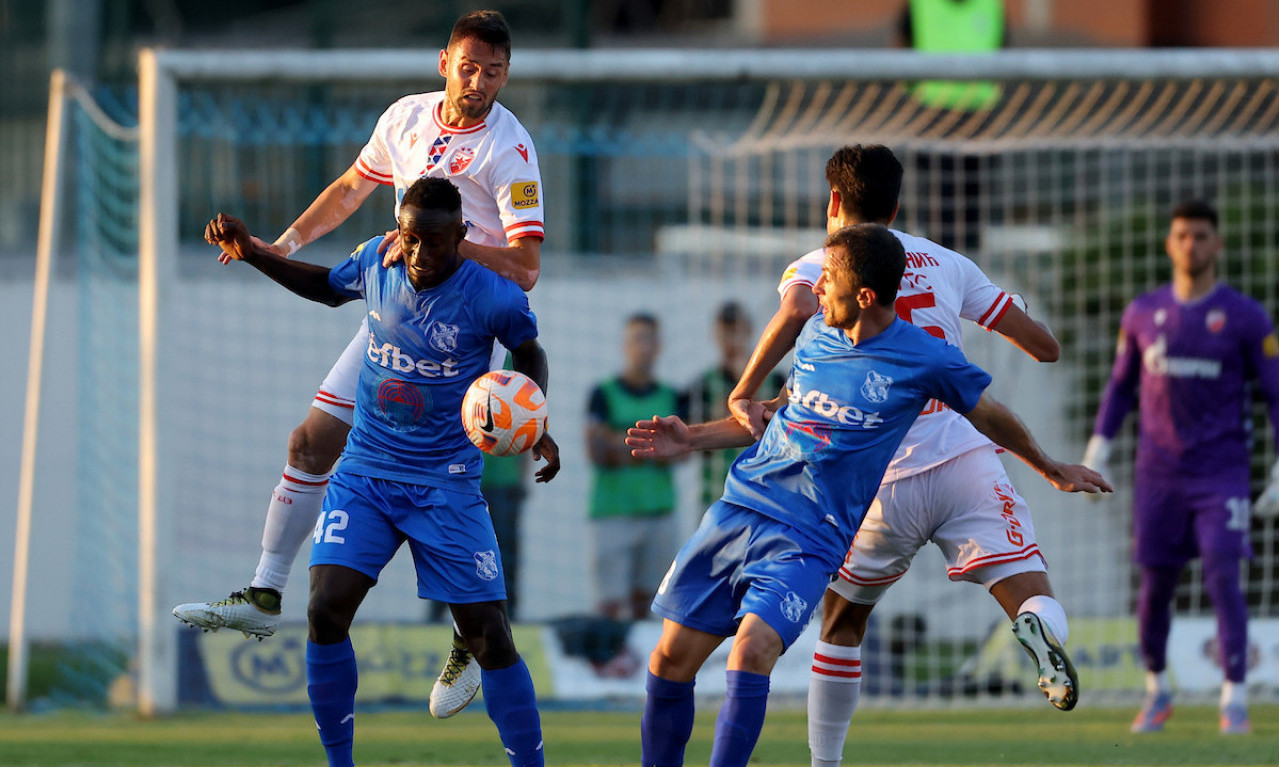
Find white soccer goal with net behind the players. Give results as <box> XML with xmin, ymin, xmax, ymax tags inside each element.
<box><xmin>17</xmin><ymin>51</ymin><xmax>1279</xmax><ymax>709</ymax></box>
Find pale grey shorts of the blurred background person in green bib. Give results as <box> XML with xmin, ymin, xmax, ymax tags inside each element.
<box><xmin>591</xmin><ymin>514</ymin><xmax>679</xmax><ymax>605</ymax></box>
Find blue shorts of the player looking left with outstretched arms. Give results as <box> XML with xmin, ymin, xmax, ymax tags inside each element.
<box><xmin>652</xmin><ymin>501</ymin><xmax>848</xmax><ymax>647</ymax></box>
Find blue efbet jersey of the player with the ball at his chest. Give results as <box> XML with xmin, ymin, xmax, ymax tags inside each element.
<box><xmin>329</xmin><ymin>238</ymin><xmax>537</xmax><ymax>492</ymax></box>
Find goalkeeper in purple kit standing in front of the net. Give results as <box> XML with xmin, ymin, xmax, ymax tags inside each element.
<box><xmin>1083</xmin><ymin>201</ymin><xmax>1279</xmax><ymax>734</ymax></box>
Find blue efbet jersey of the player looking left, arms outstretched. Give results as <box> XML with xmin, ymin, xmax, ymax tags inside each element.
<box><xmin>724</xmin><ymin>313</ymin><xmax>990</xmax><ymax>556</ymax></box>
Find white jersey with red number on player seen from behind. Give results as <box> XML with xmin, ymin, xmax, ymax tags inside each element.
<box><xmin>778</xmin><ymin>229</ymin><xmax>1012</xmax><ymax>482</ymax></box>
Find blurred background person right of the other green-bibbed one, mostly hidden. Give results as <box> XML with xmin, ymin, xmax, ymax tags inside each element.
<box><xmin>688</xmin><ymin>300</ymin><xmax>787</xmax><ymax>506</ymax></box>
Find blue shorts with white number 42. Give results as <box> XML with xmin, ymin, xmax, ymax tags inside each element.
<box><xmin>311</xmin><ymin>470</ymin><xmax>506</xmax><ymax>605</ymax></box>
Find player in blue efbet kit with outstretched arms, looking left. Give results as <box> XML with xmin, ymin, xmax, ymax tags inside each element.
<box><xmin>628</xmin><ymin>224</ymin><xmax>1109</xmax><ymax>767</ymax></box>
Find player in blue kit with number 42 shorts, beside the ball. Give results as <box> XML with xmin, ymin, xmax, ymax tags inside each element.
<box><xmin>205</xmin><ymin>176</ymin><xmax>560</xmax><ymax>767</ymax></box>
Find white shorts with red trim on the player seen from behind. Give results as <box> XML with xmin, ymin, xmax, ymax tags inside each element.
<box><xmin>830</xmin><ymin>446</ymin><xmax>1046</xmax><ymax>605</ymax></box>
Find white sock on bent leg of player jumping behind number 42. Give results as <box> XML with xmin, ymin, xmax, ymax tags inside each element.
<box><xmin>249</xmin><ymin>465</ymin><xmax>329</xmax><ymax>593</ymax></box>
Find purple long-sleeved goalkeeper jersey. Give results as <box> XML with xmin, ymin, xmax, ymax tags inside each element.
<box><xmin>1094</xmin><ymin>284</ymin><xmax>1279</xmax><ymax>481</ymax></box>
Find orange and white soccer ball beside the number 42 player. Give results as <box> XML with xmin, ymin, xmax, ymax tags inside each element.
<box><xmin>462</xmin><ymin>371</ymin><xmax>546</xmax><ymax>455</ymax></box>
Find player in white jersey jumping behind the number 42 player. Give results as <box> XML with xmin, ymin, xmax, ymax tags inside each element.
<box><xmin>173</xmin><ymin>10</ymin><xmax>545</xmax><ymax>716</ymax></box>
